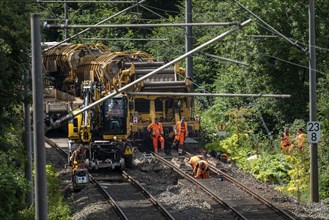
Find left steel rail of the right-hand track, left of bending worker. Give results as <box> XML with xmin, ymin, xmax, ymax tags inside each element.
<box><xmin>153</xmin><ymin>153</ymin><xmax>247</xmax><ymax>220</ymax></box>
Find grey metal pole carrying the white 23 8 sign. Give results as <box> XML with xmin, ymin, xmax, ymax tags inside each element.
<box><xmin>309</xmin><ymin>0</ymin><xmax>319</xmax><ymax>202</ymax></box>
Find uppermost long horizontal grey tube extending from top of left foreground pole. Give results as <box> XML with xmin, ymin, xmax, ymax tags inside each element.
<box><xmin>43</xmin><ymin>22</ymin><xmax>239</xmax><ymax>29</ymax></box>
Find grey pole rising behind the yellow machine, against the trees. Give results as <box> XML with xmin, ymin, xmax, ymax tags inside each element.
<box><xmin>185</xmin><ymin>0</ymin><xmax>193</xmax><ymax>91</ymax></box>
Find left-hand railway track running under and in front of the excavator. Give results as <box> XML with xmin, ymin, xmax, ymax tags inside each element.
<box><xmin>45</xmin><ymin>137</ymin><xmax>175</xmax><ymax>220</ymax></box>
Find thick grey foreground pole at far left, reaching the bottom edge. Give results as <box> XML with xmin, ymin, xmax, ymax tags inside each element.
<box><xmin>31</xmin><ymin>14</ymin><xmax>48</xmax><ymax>220</ymax></box>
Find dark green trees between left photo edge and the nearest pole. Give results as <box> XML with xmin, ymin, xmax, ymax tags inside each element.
<box><xmin>0</xmin><ymin>0</ymin><xmax>33</xmax><ymax>219</ymax></box>
